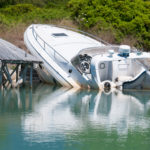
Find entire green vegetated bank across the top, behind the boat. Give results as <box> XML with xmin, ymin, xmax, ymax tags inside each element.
<box><xmin>0</xmin><ymin>0</ymin><xmax>150</xmax><ymax>51</ymax></box>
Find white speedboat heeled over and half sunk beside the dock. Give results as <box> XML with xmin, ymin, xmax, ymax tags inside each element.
<box><xmin>24</xmin><ymin>24</ymin><xmax>150</xmax><ymax>89</ymax></box>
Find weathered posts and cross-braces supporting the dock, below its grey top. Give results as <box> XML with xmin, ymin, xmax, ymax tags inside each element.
<box><xmin>0</xmin><ymin>60</ymin><xmax>40</xmax><ymax>88</ymax></box>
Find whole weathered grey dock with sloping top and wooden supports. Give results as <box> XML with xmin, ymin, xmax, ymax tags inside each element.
<box><xmin>0</xmin><ymin>39</ymin><xmax>42</xmax><ymax>87</ymax></box>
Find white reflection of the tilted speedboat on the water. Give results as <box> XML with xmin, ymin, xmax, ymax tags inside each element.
<box><xmin>19</xmin><ymin>85</ymin><xmax>150</xmax><ymax>142</ymax></box>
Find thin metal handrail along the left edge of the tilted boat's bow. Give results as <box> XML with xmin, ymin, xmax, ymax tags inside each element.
<box><xmin>32</xmin><ymin>26</ymin><xmax>69</xmax><ymax>64</ymax></box>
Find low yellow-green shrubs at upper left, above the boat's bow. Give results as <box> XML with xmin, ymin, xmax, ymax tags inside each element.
<box><xmin>0</xmin><ymin>4</ymin><xmax>69</xmax><ymax>24</ymax></box>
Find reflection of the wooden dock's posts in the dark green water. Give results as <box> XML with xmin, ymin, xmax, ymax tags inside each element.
<box><xmin>0</xmin><ymin>88</ymin><xmax>32</xmax><ymax>113</ymax></box>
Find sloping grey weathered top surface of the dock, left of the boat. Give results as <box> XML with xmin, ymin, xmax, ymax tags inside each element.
<box><xmin>0</xmin><ymin>39</ymin><xmax>42</xmax><ymax>63</ymax></box>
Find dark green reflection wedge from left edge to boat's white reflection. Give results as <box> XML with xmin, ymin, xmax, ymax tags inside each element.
<box><xmin>0</xmin><ymin>84</ymin><xmax>58</xmax><ymax>114</ymax></box>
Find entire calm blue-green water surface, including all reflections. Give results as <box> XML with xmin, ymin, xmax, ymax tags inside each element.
<box><xmin>0</xmin><ymin>85</ymin><xmax>150</xmax><ymax>150</ymax></box>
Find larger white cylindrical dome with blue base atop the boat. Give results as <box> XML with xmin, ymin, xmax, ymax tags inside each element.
<box><xmin>119</xmin><ymin>45</ymin><xmax>131</xmax><ymax>58</ymax></box>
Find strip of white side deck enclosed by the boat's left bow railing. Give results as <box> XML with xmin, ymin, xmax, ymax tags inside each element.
<box><xmin>32</xmin><ymin>26</ymin><xmax>69</xmax><ymax>64</ymax></box>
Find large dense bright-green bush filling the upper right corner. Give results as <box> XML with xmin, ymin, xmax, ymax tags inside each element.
<box><xmin>68</xmin><ymin>0</ymin><xmax>150</xmax><ymax>50</ymax></box>
